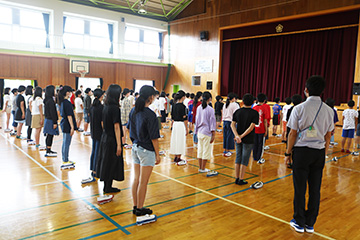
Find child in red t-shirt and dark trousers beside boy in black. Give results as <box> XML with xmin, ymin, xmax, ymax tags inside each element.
<box><xmin>253</xmin><ymin>93</ymin><xmax>270</xmax><ymax>164</ymax></box>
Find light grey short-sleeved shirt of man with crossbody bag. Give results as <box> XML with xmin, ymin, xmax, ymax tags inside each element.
<box><xmin>287</xmin><ymin>96</ymin><xmax>334</xmax><ymax>149</ymax></box>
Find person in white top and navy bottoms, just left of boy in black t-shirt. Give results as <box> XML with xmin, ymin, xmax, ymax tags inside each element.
<box><xmin>222</xmin><ymin>93</ymin><xmax>240</xmax><ymax>157</ymax></box>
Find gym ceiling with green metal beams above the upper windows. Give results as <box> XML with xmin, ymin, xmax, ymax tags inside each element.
<box><xmin>62</xmin><ymin>0</ymin><xmax>193</xmax><ymax>22</ymax></box>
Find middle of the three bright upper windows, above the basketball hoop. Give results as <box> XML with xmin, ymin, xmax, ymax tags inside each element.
<box><xmin>63</xmin><ymin>16</ymin><xmax>111</xmax><ymax>53</ymax></box>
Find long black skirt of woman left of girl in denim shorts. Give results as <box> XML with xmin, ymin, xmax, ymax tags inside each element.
<box><xmin>96</xmin><ymin>132</ymin><xmax>124</xmax><ymax>181</ymax></box>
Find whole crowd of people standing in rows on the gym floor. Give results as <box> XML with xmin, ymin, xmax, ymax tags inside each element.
<box><xmin>3</xmin><ymin>76</ymin><xmax>354</xmax><ymax>232</ymax></box>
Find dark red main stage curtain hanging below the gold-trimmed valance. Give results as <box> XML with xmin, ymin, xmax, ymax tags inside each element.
<box><xmin>221</xmin><ymin>27</ymin><xmax>358</xmax><ymax>104</ymax></box>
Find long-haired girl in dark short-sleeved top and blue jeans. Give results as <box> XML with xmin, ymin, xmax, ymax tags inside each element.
<box><xmin>58</xmin><ymin>86</ymin><xmax>77</xmax><ymax>165</ymax></box>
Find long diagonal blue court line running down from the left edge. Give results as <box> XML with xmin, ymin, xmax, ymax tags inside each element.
<box><xmin>1</xmin><ymin>134</ymin><xmax>131</xmax><ymax>235</ymax></box>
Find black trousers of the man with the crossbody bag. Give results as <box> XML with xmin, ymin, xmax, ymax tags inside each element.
<box><xmin>293</xmin><ymin>147</ymin><xmax>325</xmax><ymax>227</ymax></box>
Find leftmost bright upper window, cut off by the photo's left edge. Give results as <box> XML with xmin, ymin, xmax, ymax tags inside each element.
<box><xmin>0</xmin><ymin>5</ymin><xmax>47</xmax><ymax>47</ymax></box>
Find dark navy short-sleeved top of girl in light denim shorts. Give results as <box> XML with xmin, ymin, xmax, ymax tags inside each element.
<box><xmin>127</xmin><ymin>107</ymin><xmax>160</xmax><ymax>151</ymax></box>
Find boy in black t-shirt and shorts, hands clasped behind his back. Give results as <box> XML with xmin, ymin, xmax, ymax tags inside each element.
<box><xmin>231</xmin><ymin>93</ymin><xmax>259</xmax><ymax>185</ymax></box>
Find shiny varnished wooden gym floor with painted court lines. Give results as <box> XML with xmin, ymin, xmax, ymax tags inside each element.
<box><xmin>0</xmin><ymin>114</ymin><xmax>360</xmax><ymax>240</ymax></box>
